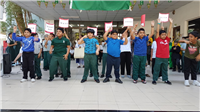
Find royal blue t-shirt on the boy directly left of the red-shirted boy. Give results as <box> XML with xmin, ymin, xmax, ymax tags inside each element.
<box><xmin>133</xmin><ymin>36</ymin><xmax>149</xmax><ymax>56</ymax></box>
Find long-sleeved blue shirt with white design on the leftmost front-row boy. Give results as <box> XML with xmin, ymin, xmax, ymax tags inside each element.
<box><xmin>12</xmin><ymin>33</ymin><xmax>40</xmax><ymax>52</ymax></box>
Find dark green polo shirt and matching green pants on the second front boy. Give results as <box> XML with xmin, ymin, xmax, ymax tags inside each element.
<box><xmin>50</xmin><ymin>37</ymin><xmax>70</xmax><ymax>79</ymax></box>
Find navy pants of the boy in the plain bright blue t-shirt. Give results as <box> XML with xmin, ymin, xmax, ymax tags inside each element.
<box><xmin>106</xmin><ymin>54</ymin><xmax>120</xmax><ymax>78</ymax></box>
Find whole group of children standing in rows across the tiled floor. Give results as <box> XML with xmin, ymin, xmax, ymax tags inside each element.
<box><xmin>5</xmin><ymin>18</ymin><xmax>200</xmax><ymax>86</ymax></box>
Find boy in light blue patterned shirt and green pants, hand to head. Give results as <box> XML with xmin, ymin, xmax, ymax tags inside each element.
<box><xmin>78</xmin><ymin>29</ymin><xmax>100</xmax><ymax>83</ymax></box>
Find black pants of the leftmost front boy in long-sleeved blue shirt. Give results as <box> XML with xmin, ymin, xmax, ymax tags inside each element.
<box><xmin>22</xmin><ymin>52</ymin><xmax>35</xmax><ymax>79</ymax></box>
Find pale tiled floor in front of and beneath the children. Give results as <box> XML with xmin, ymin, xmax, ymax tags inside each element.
<box><xmin>0</xmin><ymin>61</ymin><xmax>200</xmax><ymax>111</ymax></box>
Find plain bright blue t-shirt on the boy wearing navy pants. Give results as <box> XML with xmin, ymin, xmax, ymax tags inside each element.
<box><xmin>106</xmin><ymin>38</ymin><xmax>124</xmax><ymax>57</ymax></box>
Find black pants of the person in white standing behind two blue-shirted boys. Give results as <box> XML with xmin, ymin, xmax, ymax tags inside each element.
<box><xmin>120</xmin><ymin>52</ymin><xmax>131</xmax><ymax>75</ymax></box>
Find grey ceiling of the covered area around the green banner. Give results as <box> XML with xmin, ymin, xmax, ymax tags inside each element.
<box><xmin>12</xmin><ymin>0</ymin><xmax>193</xmax><ymax>21</ymax></box>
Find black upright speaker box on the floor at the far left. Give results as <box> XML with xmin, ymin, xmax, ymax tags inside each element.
<box><xmin>3</xmin><ymin>54</ymin><xmax>12</xmax><ymax>74</ymax></box>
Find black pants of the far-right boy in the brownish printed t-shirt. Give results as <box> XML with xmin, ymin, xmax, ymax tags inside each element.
<box><xmin>184</xmin><ymin>57</ymin><xmax>198</xmax><ymax>80</ymax></box>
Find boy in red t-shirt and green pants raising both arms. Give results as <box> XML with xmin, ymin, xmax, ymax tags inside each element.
<box><xmin>152</xmin><ymin>18</ymin><xmax>173</xmax><ymax>85</ymax></box>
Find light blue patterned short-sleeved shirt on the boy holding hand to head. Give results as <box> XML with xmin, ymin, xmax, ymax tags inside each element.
<box><xmin>83</xmin><ymin>38</ymin><xmax>99</xmax><ymax>54</ymax></box>
